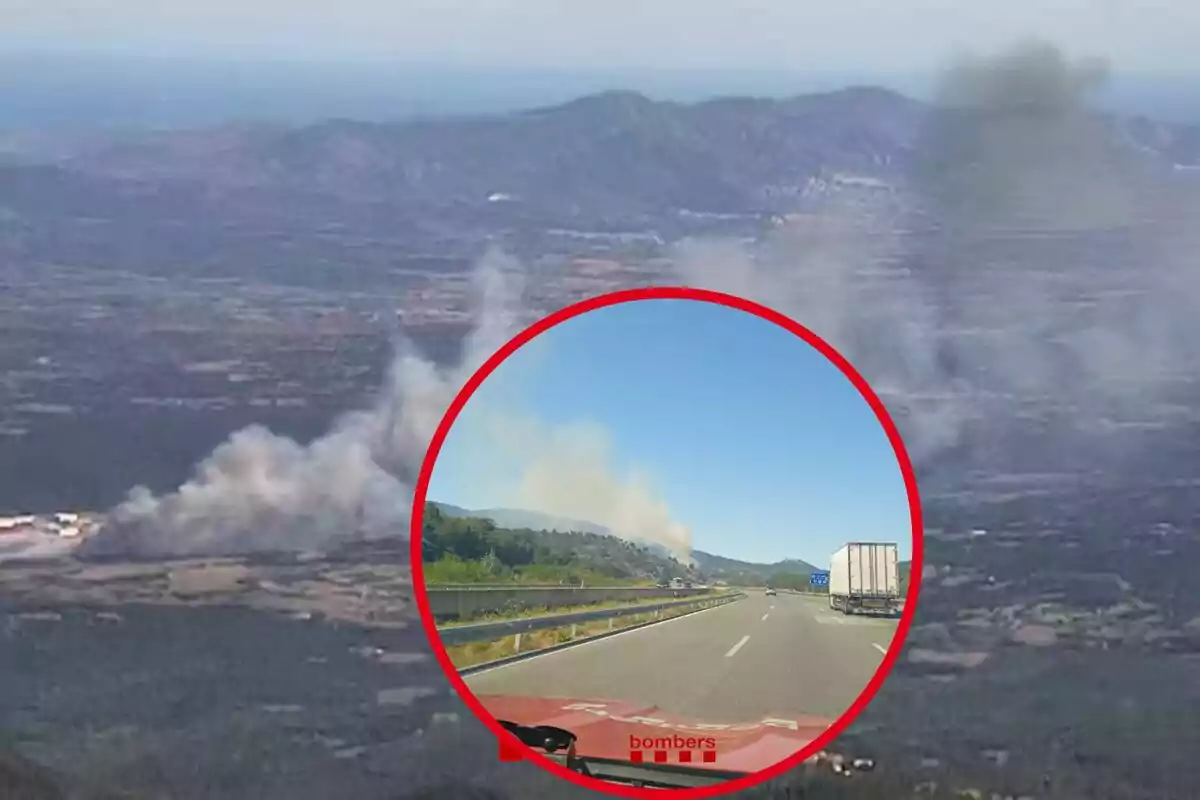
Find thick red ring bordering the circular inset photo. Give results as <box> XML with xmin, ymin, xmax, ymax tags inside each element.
<box><xmin>409</xmin><ymin>287</ymin><xmax>924</xmax><ymax>800</ymax></box>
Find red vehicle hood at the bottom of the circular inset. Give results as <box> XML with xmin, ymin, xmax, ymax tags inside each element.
<box><xmin>476</xmin><ymin>694</ymin><xmax>833</xmax><ymax>774</ymax></box>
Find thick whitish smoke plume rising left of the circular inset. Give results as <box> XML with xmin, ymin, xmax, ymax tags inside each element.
<box><xmin>80</xmin><ymin>252</ymin><xmax>521</xmax><ymax>557</ymax></box>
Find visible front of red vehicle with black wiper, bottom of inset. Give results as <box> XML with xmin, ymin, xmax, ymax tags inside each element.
<box><xmin>476</xmin><ymin>694</ymin><xmax>833</xmax><ymax>789</ymax></box>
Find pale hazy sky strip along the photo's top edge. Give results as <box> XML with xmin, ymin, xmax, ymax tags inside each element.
<box><xmin>9</xmin><ymin>0</ymin><xmax>1200</xmax><ymax>72</ymax></box>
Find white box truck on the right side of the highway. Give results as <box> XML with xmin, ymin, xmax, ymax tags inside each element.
<box><xmin>829</xmin><ymin>542</ymin><xmax>900</xmax><ymax>616</ymax></box>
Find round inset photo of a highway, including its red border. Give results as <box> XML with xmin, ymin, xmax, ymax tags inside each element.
<box><xmin>413</xmin><ymin>288</ymin><xmax>922</xmax><ymax>798</ymax></box>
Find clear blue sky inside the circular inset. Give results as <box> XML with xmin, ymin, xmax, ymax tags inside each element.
<box><xmin>428</xmin><ymin>300</ymin><xmax>912</xmax><ymax>565</ymax></box>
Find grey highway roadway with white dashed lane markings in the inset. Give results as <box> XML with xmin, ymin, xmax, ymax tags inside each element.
<box><xmin>464</xmin><ymin>590</ymin><xmax>896</xmax><ymax>723</ymax></box>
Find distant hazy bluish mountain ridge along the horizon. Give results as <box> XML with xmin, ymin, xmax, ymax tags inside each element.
<box><xmin>59</xmin><ymin>85</ymin><xmax>1200</xmax><ymax>190</ymax></box>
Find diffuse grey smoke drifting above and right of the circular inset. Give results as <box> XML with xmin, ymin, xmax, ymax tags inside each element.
<box><xmin>678</xmin><ymin>42</ymin><xmax>1200</xmax><ymax>472</ymax></box>
